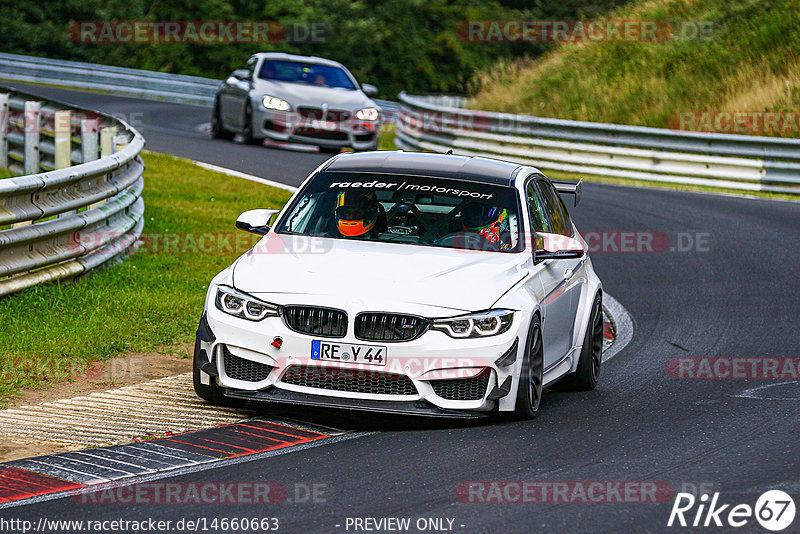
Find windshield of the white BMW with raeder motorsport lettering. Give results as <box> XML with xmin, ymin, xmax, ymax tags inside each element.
<box><xmin>276</xmin><ymin>173</ymin><xmax>521</xmax><ymax>252</ymax></box>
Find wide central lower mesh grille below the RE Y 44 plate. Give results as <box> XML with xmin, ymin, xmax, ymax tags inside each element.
<box><xmin>281</xmin><ymin>365</ymin><xmax>417</xmax><ymax>395</ymax></box>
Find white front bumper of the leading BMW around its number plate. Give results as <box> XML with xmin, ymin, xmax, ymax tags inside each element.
<box><xmin>196</xmin><ymin>304</ymin><xmax>527</xmax><ymax>415</ymax></box>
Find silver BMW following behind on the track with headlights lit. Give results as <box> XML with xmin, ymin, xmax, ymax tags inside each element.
<box><xmin>211</xmin><ymin>53</ymin><xmax>381</xmax><ymax>152</ymax></box>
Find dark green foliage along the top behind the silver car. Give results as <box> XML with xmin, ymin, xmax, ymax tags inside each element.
<box><xmin>0</xmin><ymin>0</ymin><xmax>622</xmax><ymax>98</ymax></box>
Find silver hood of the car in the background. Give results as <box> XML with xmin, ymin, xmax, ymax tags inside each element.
<box><xmin>253</xmin><ymin>79</ymin><xmax>377</xmax><ymax>111</ymax></box>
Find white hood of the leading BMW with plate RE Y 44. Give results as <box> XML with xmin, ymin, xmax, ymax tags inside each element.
<box><xmin>233</xmin><ymin>233</ymin><xmax>527</xmax><ymax>317</ymax></box>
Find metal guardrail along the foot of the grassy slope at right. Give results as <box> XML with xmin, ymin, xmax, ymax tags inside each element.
<box><xmin>396</xmin><ymin>93</ymin><xmax>800</xmax><ymax>194</ymax></box>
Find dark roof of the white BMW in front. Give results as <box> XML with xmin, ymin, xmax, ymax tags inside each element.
<box><xmin>322</xmin><ymin>151</ymin><xmax>538</xmax><ymax>187</ymax></box>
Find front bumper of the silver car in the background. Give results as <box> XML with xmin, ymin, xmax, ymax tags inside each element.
<box><xmin>253</xmin><ymin>107</ymin><xmax>381</xmax><ymax>150</ymax></box>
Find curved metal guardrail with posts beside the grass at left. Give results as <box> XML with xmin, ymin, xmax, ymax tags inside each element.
<box><xmin>0</xmin><ymin>86</ymin><xmax>144</xmax><ymax>297</ymax></box>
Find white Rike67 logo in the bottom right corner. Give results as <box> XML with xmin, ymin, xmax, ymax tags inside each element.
<box><xmin>667</xmin><ymin>490</ymin><xmax>796</xmax><ymax>532</ymax></box>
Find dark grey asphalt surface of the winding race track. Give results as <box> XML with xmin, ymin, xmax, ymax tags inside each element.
<box><xmin>6</xmin><ymin>85</ymin><xmax>800</xmax><ymax>533</ymax></box>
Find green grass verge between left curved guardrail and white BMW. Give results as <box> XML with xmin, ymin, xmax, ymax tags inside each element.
<box><xmin>0</xmin><ymin>153</ymin><xmax>290</xmax><ymax>406</ymax></box>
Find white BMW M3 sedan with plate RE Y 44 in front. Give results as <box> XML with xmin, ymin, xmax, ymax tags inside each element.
<box><xmin>193</xmin><ymin>152</ymin><xmax>603</xmax><ymax>419</ymax></box>
